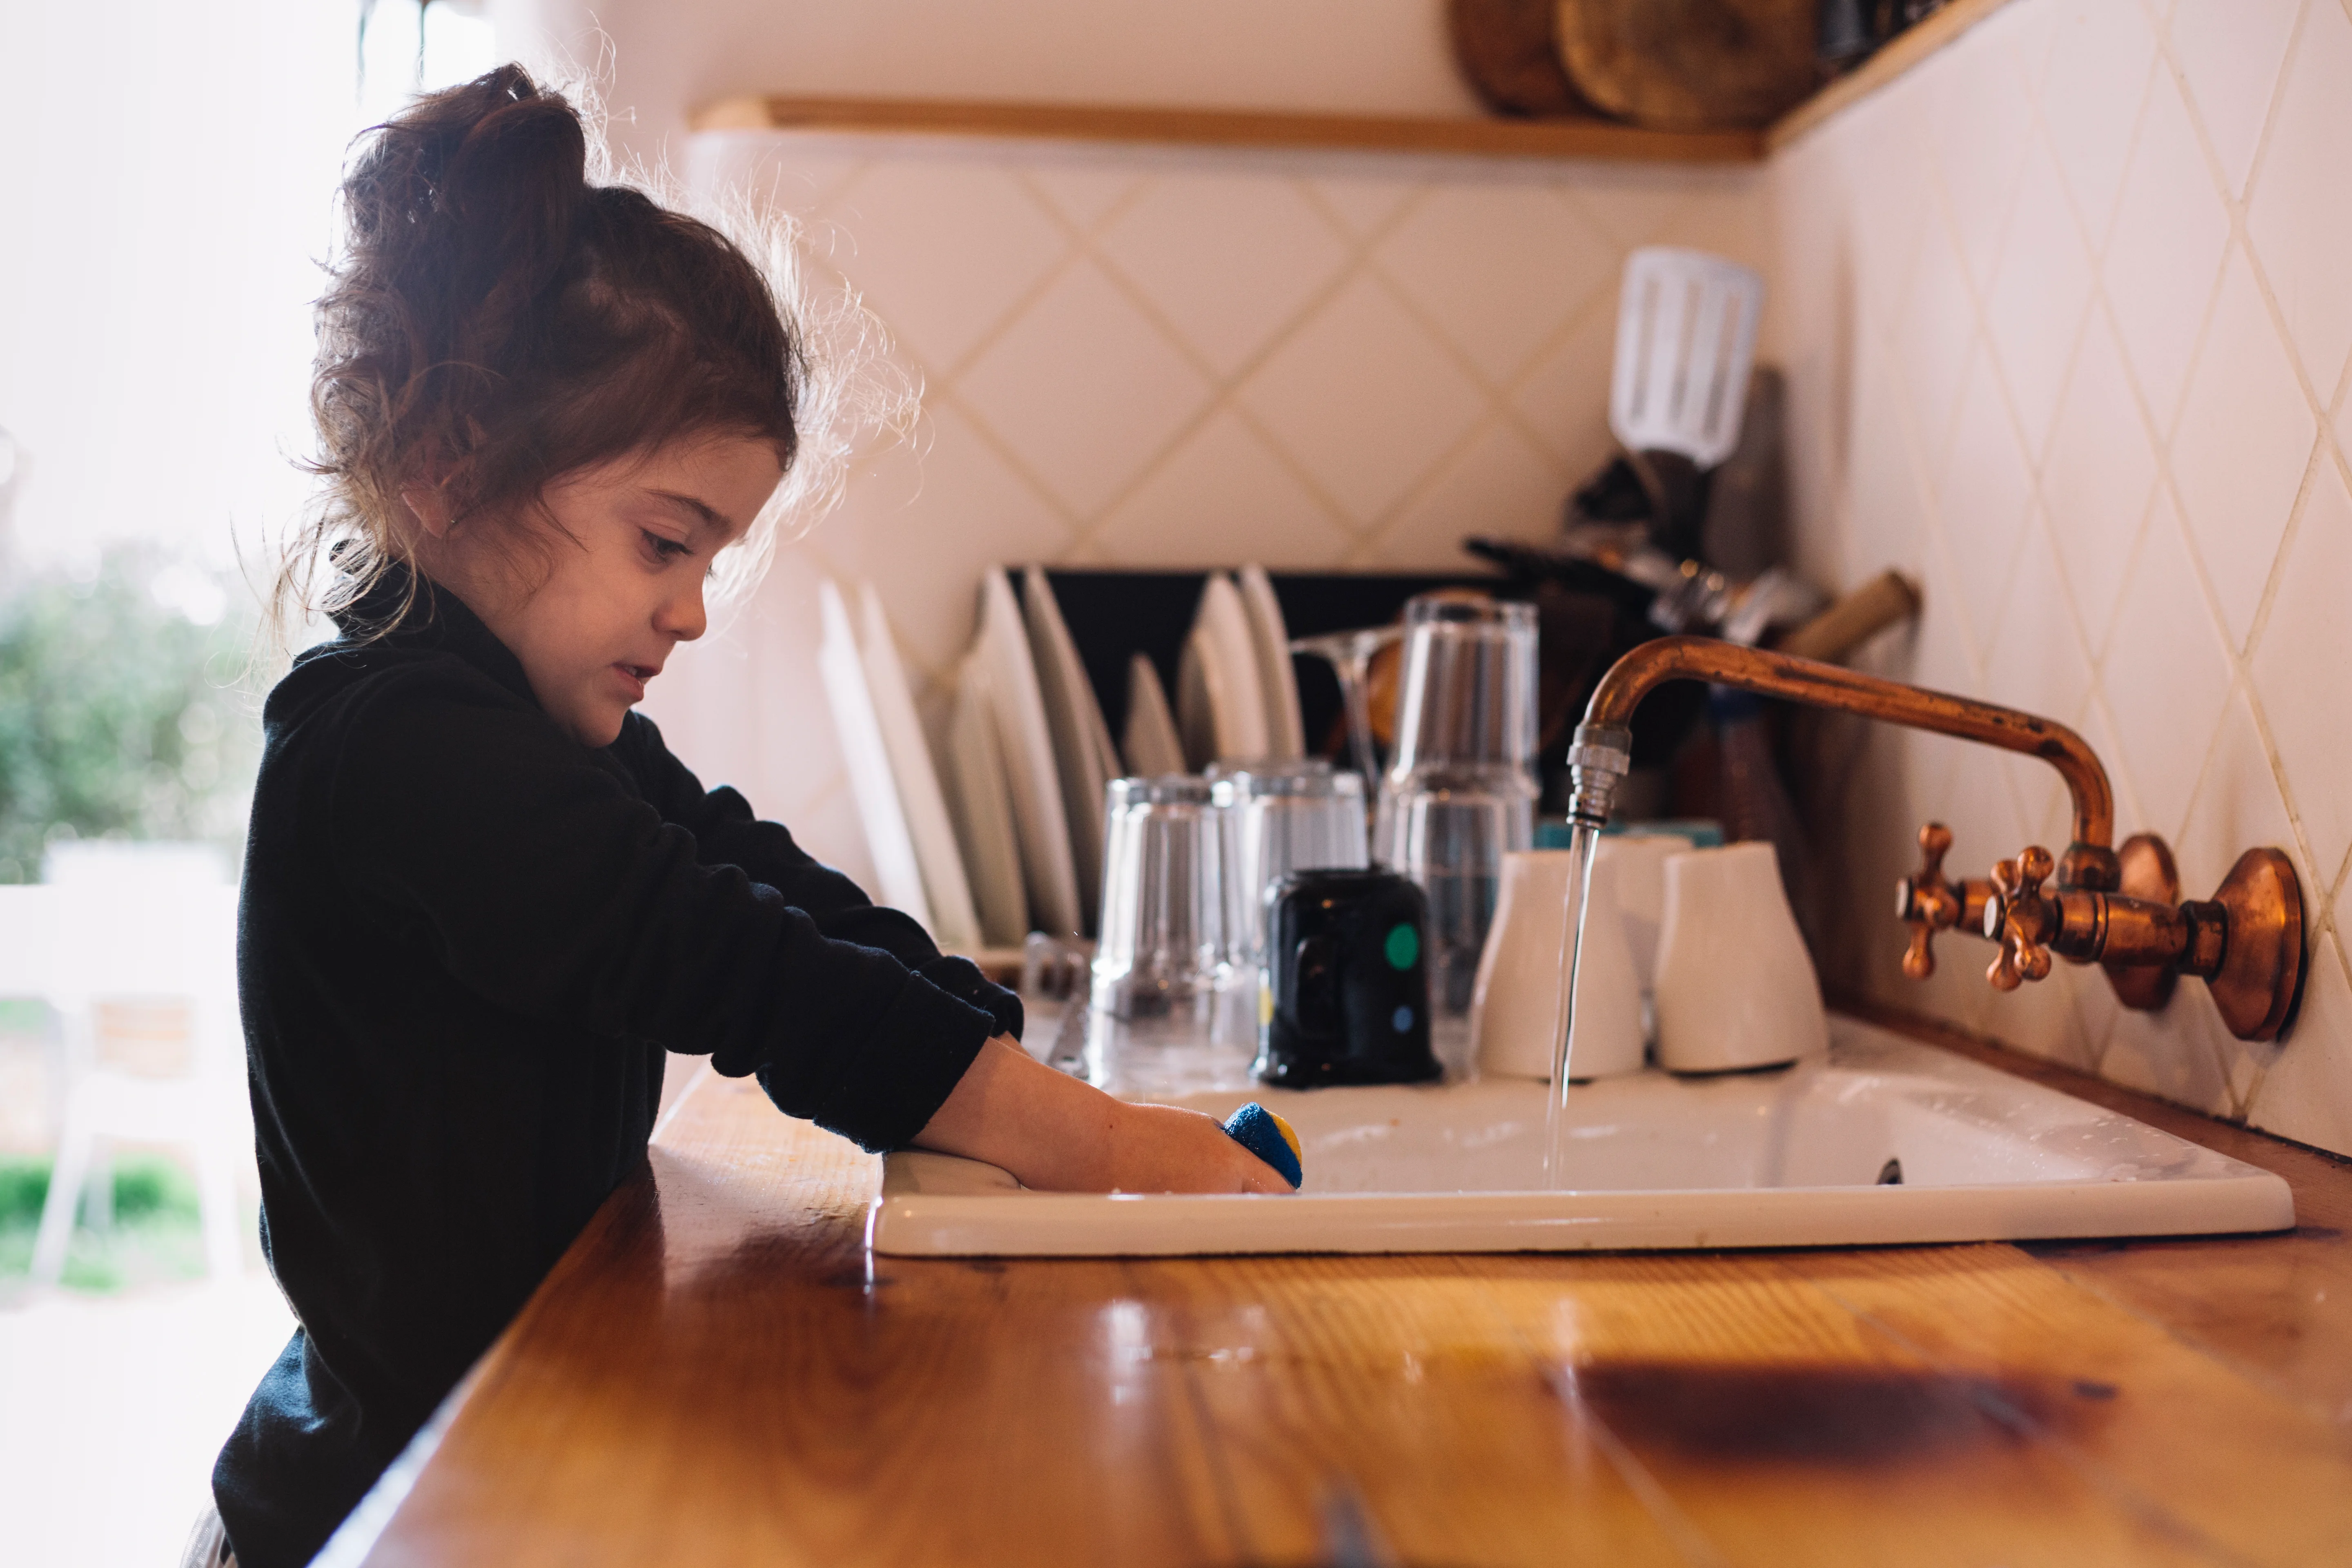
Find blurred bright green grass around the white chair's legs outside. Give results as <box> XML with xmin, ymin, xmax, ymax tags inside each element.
<box><xmin>0</xmin><ymin>1154</ymin><xmax>205</xmax><ymax>1300</ymax></box>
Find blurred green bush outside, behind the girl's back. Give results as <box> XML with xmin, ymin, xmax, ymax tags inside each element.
<box><xmin>0</xmin><ymin>546</ymin><xmax>261</xmax><ymax>884</ymax></box>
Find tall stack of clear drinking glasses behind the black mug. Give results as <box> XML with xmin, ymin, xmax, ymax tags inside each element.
<box><xmin>1374</xmin><ymin>595</ymin><xmax>1536</xmax><ymax>1018</ymax></box>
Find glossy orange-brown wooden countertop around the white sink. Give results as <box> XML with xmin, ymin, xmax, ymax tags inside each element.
<box><xmin>343</xmin><ymin>1018</ymin><xmax>2352</xmax><ymax>1568</ymax></box>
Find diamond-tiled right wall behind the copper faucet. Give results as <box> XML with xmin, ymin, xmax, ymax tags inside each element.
<box><xmin>1766</xmin><ymin>0</ymin><xmax>2352</xmax><ymax>1152</ymax></box>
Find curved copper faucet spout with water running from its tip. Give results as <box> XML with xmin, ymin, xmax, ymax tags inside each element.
<box><xmin>1569</xmin><ymin>637</ymin><xmax>2122</xmax><ymax>891</ymax></box>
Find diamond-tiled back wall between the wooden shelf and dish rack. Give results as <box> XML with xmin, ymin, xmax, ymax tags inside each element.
<box><xmin>649</xmin><ymin>131</ymin><xmax>1766</xmax><ymax>902</ymax></box>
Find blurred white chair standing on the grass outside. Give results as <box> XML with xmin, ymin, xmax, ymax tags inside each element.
<box><xmin>24</xmin><ymin>875</ymin><xmax>252</xmax><ymax>1281</ymax></box>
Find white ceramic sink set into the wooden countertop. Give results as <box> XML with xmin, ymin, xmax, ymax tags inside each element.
<box><xmin>866</xmin><ymin>1018</ymin><xmax>2296</xmax><ymax>1258</ymax></box>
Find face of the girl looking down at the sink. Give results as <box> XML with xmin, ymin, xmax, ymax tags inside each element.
<box><xmin>412</xmin><ymin>437</ymin><xmax>783</xmax><ymax>745</ymax></box>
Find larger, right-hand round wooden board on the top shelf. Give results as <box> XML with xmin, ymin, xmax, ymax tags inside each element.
<box><xmin>1555</xmin><ymin>0</ymin><xmax>1816</xmax><ymax>131</ymax></box>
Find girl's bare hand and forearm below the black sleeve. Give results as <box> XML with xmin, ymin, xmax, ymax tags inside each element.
<box><xmin>915</xmin><ymin>1034</ymin><xmax>1291</xmax><ymax>1192</ymax></box>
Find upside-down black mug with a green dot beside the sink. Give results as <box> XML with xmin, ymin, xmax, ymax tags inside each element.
<box><xmin>1256</xmin><ymin>870</ymin><xmax>1439</xmax><ymax>1089</ymax></box>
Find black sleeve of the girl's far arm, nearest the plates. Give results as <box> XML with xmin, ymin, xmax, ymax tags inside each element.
<box><xmin>612</xmin><ymin>712</ymin><xmax>1023</xmax><ymax>1039</ymax></box>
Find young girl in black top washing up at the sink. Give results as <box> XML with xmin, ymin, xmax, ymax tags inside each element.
<box><xmin>209</xmin><ymin>66</ymin><xmax>1287</xmax><ymax>1568</ymax></box>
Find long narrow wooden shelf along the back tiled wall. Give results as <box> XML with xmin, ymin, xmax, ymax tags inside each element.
<box><xmin>691</xmin><ymin>94</ymin><xmax>1764</xmax><ymax>162</ymax></box>
